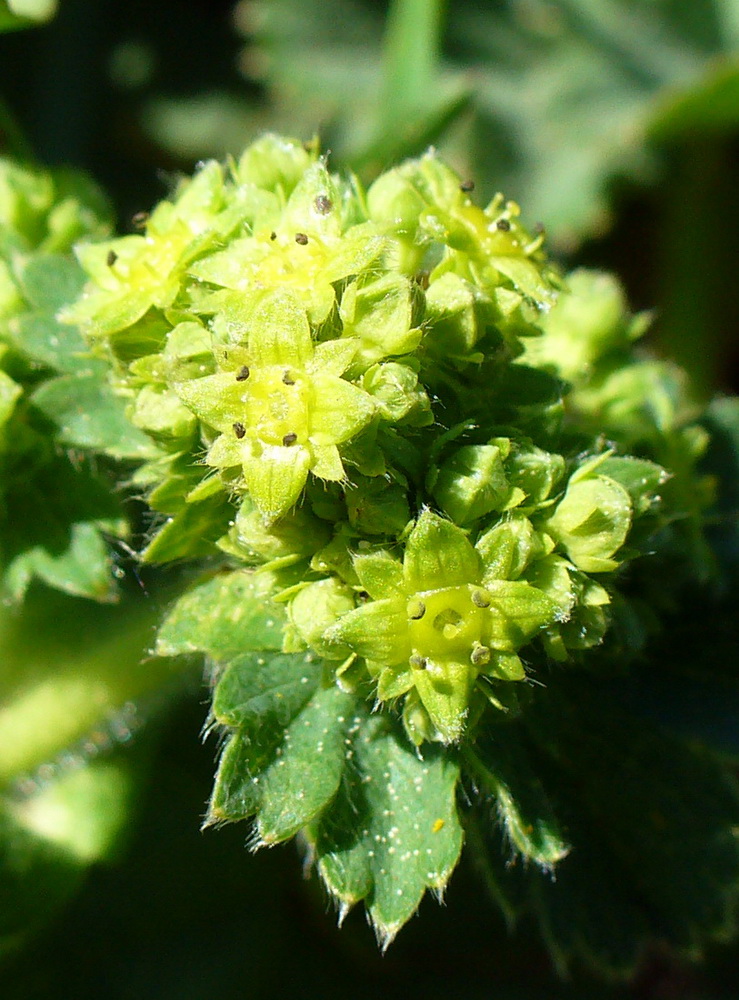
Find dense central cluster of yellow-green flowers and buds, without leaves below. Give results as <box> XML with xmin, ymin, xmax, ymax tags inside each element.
<box><xmin>63</xmin><ymin>136</ymin><xmax>712</xmax><ymax>743</ymax></box>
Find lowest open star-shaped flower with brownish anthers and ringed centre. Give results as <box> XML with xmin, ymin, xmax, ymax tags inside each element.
<box><xmin>327</xmin><ymin>510</ymin><xmax>556</xmax><ymax>743</ymax></box>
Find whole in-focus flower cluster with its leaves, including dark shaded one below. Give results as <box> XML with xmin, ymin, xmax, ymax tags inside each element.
<box><xmin>7</xmin><ymin>135</ymin><xmax>739</xmax><ymax>972</ymax></box>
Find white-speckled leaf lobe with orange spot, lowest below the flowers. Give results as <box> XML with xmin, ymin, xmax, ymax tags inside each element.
<box><xmin>309</xmin><ymin>716</ymin><xmax>462</xmax><ymax>947</ymax></box>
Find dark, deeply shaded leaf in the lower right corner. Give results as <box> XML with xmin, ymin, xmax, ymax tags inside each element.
<box><xmin>527</xmin><ymin>682</ymin><xmax>739</xmax><ymax>972</ymax></box>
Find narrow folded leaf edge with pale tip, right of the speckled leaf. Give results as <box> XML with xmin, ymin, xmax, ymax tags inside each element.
<box><xmin>463</xmin><ymin>724</ymin><xmax>570</xmax><ymax>870</ymax></box>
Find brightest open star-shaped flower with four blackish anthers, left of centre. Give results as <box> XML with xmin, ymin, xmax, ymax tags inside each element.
<box><xmin>174</xmin><ymin>291</ymin><xmax>375</xmax><ymax>521</ymax></box>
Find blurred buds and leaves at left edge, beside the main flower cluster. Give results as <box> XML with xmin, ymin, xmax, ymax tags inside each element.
<box><xmin>0</xmin><ymin>160</ymin><xmax>145</xmax><ymax>600</ymax></box>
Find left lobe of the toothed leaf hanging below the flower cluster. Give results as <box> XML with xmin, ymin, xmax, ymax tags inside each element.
<box><xmin>207</xmin><ymin>655</ymin><xmax>355</xmax><ymax>845</ymax></box>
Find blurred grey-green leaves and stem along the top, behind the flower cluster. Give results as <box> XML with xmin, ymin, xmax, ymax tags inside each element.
<box><xmin>148</xmin><ymin>0</ymin><xmax>739</xmax><ymax>246</ymax></box>
